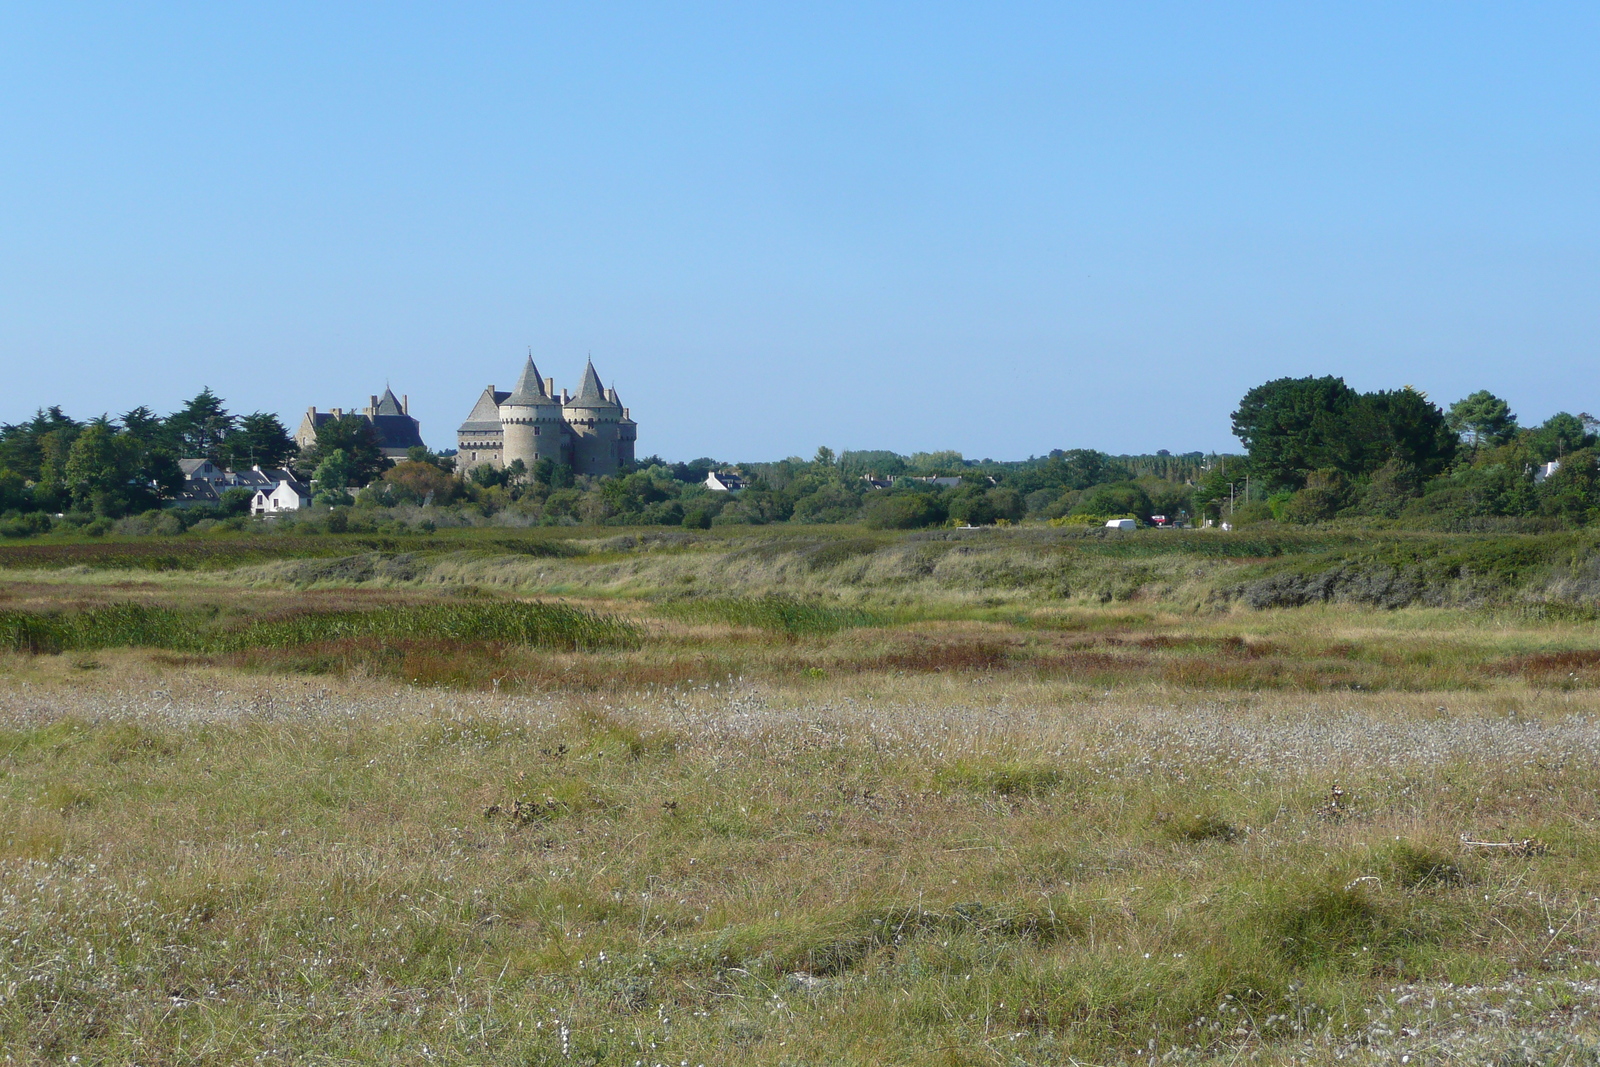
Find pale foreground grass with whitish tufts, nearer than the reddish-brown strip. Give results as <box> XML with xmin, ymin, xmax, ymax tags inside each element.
<box><xmin>0</xmin><ymin>675</ymin><xmax>1600</xmax><ymax>1064</ymax></box>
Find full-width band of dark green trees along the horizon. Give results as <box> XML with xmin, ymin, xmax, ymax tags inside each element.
<box><xmin>12</xmin><ymin>376</ymin><xmax>1600</xmax><ymax>536</ymax></box>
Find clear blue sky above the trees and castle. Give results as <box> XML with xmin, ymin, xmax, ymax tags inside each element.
<box><xmin>0</xmin><ymin>0</ymin><xmax>1600</xmax><ymax>459</ymax></box>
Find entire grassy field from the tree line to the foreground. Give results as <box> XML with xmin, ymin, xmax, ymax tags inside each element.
<box><xmin>0</xmin><ymin>528</ymin><xmax>1600</xmax><ymax>1065</ymax></box>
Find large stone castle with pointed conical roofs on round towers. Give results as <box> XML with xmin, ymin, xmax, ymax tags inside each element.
<box><xmin>456</xmin><ymin>355</ymin><xmax>638</xmax><ymax>475</ymax></box>
